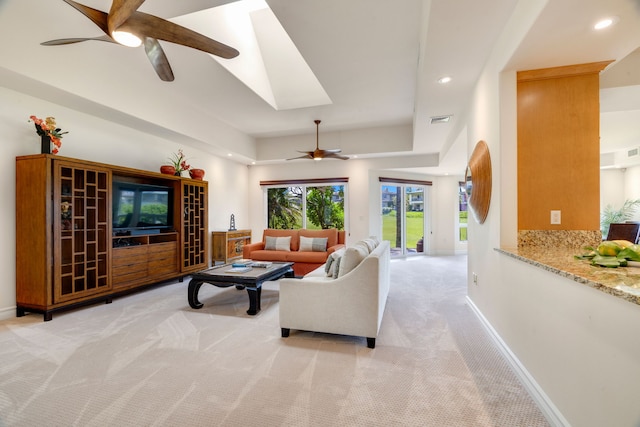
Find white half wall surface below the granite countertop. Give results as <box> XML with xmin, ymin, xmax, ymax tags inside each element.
<box><xmin>496</xmin><ymin>254</ymin><xmax>640</xmax><ymax>427</ymax></box>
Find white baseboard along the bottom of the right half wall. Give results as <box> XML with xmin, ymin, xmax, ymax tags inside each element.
<box><xmin>466</xmin><ymin>295</ymin><xmax>571</xmax><ymax>427</ymax></box>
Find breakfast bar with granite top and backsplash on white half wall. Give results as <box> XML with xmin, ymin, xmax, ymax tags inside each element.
<box><xmin>484</xmin><ymin>234</ymin><xmax>640</xmax><ymax>426</ymax></box>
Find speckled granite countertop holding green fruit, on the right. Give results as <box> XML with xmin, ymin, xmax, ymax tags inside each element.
<box><xmin>496</xmin><ymin>246</ymin><xmax>640</xmax><ymax>305</ymax></box>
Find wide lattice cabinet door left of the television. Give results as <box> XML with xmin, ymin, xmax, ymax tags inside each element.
<box><xmin>53</xmin><ymin>161</ymin><xmax>111</xmax><ymax>303</ymax></box>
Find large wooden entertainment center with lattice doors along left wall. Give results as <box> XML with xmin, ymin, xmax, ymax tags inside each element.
<box><xmin>16</xmin><ymin>154</ymin><xmax>209</xmax><ymax>321</ymax></box>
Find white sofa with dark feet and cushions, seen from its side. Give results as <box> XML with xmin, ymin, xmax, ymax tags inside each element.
<box><xmin>279</xmin><ymin>239</ymin><xmax>390</xmax><ymax>348</ymax></box>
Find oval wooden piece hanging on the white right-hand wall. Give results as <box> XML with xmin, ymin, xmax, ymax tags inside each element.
<box><xmin>464</xmin><ymin>141</ymin><xmax>491</xmax><ymax>224</ymax></box>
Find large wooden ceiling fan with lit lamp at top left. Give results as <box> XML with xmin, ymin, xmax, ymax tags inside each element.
<box><xmin>41</xmin><ymin>0</ymin><xmax>239</xmax><ymax>82</ymax></box>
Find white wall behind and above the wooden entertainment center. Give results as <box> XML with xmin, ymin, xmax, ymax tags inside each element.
<box><xmin>0</xmin><ymin>87</ymin><xmax>248</xmax><ymax>319</ymax></box>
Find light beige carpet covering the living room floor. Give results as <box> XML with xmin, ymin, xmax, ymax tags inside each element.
<box><xmin>0</xmin><ymin>256</ymin><xmax>548</xmax><ymax>427</ymax></box>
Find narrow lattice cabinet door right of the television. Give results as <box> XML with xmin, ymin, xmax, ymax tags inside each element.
<box><xmin>181</xmin><ymin>180</ymin><xmax>208</xmax><ymax>273</ymax></box>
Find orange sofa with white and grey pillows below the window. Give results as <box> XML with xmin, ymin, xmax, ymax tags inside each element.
<box><xmin>242</xmin><ymin>228</ymin><xmax>345</xmax><ymax>276</ymax></box>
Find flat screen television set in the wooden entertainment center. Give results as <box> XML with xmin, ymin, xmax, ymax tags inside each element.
<box><xmin>112</xmin><ymin>181</ymin><xmax>173</xmax><ymax>234</ymax></box>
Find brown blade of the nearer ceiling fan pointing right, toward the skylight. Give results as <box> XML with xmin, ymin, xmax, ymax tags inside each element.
<box><xmin>119</xmin><ymin>12</ymin><xmax>240</xmax><ymax>59</ymax></box>
